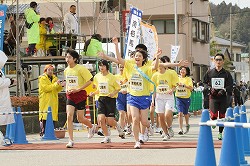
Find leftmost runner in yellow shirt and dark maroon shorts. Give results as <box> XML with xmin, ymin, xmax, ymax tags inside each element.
<box><xmin>64</xmin><ymin>50</ymin><xmax>95</xmax><ymax>148</ymax></box>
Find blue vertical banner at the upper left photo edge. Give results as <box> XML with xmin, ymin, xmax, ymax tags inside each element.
<box><xmin>0</xmin><ymin>5</ymin><xmax>7</xmax><ymax>50</ymax></box>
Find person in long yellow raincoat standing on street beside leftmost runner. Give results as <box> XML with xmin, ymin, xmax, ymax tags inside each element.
<box><xmin>38</xmin><ymin>64</ymin><xmax>66</xmax><ymax>136</ymax></box>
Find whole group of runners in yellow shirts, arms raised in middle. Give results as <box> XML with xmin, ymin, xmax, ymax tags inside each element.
<box><xmin>64</xmin><ymin>38</ymin><xmax>193</xmax><ymax>149</ymax></box>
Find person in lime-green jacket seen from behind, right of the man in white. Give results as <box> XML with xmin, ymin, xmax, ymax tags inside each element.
<box><xmin>84</xmin><ymin>34</ymin><xmax>103</xmax><ymax>56</ymax></box>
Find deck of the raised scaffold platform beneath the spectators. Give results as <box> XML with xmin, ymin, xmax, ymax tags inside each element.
<box><xmin>6</xmin><ymin>56</ymin><xmax>98</xmax><ymax>65</ymax></box>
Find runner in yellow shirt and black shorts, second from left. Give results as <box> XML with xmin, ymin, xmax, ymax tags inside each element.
<box><xmin>90</xmin><ymin>60</ymin><xmax>125</xmax><ymax>143</ymax></box>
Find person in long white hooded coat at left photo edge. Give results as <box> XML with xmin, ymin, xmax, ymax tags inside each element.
<box><xmin>0</xmin><ymin>51</ymin><xmax>16</xmax><ymax>137</ymax></box>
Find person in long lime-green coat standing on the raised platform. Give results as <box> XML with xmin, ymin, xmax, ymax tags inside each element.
<box><xmin>24</xmin><ymin>1</ymin><xmax>40</xmax><ymax>56</ymax></box>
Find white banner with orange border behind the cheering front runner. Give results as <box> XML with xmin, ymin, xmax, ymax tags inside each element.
<box><xmin>141</xmin><ymin>22</ymin><xmax>158</xmax><ymax>60</ymax></box>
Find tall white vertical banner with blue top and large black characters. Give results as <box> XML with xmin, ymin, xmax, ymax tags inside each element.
<box><xmin>124</xmin><ymin>7</ymin><xmax>142</xmax><ymax>59</ymax></box>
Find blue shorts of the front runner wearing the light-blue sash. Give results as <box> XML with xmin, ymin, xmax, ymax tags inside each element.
<box><xmin>130</xmin><ymin>95</ymin><xmax>151</xmax><ymax>110</ymax></box>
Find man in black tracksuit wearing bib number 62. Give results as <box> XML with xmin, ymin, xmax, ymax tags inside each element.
<box><xmin>204</xmin><ymin>53</ymin><xmax>233</xmax><ymax>140</ymax></box>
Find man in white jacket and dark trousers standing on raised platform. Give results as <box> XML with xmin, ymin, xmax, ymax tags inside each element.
<box><xmin>63</xmin><ymin>5</ymin><xmax>79</xmax><ymax>49</ymax></box>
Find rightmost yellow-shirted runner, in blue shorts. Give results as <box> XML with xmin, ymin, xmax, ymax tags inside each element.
<box><xmin>175</xmin><ymin>66</ymin><xmax>193</xmax><ymax>135</ymax></box>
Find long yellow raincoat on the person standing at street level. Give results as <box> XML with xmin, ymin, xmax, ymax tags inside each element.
<box><xmin>38</xmin><ymin>73</ymin><xmax>63</xmax><ymax>121</ymax></box>
